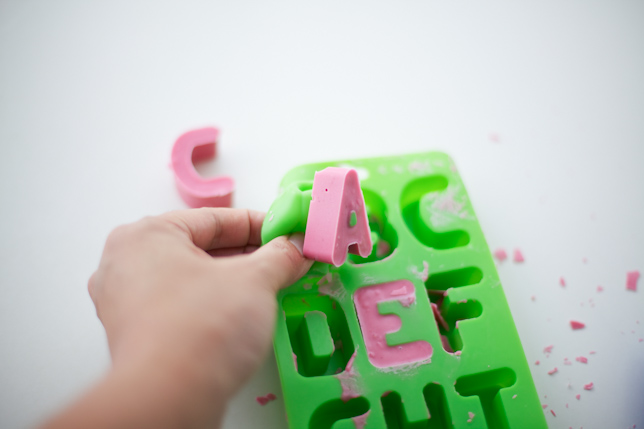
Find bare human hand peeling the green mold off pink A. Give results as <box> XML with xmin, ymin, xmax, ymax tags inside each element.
<box><xmin>44</xmin><ymin>208</ymin><xmax>312</xmax><ymax>427</ymax></box>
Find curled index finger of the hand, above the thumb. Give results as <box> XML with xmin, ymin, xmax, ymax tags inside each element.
<box><xmin>160</xmin><ymin>207</ymin><xmax>265</xmax><ymax>251</ymax></box>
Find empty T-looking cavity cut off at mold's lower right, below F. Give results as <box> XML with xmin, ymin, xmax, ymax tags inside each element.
<box><xmin>454</xmin><ymin>368</ymin><xmax>517</xmax><ymax>429</ymax></box>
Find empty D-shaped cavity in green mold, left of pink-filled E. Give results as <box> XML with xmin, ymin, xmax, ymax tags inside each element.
<box><xmin>282</xmin><ymin>293</ymin><xmax>355</xmax><ymax>377</ymax></box>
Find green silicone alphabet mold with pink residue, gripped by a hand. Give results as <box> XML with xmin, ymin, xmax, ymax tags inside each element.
<box><xmin>262</xmin><ymin>152</ymin><xmax>547</xmax><ymax>429</ymax></box>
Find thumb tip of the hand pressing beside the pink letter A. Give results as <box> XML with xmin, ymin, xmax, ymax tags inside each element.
<box><xmin>248</xmin><ymin>233</ymin><xmax>313</xmax><ymax>292</ymax></box>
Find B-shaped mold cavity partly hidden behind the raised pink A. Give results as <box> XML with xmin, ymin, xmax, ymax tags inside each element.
<box><xmin>349</xmin><ymin>188</ymin><xmax>398</xmax><ymax>264</ymax></box>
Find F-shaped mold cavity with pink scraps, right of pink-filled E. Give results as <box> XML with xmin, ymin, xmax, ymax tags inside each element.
<box><xmin>425</xmin><ymin>267</ymin><xmax>483</xmax><ymax>353</ymax></box>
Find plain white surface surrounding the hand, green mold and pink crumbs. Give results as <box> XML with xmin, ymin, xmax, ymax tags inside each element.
<box><xmin>0</xmin><ymin>0</ymin><xmax>644</xmax><ymax>429</ymax></box>
